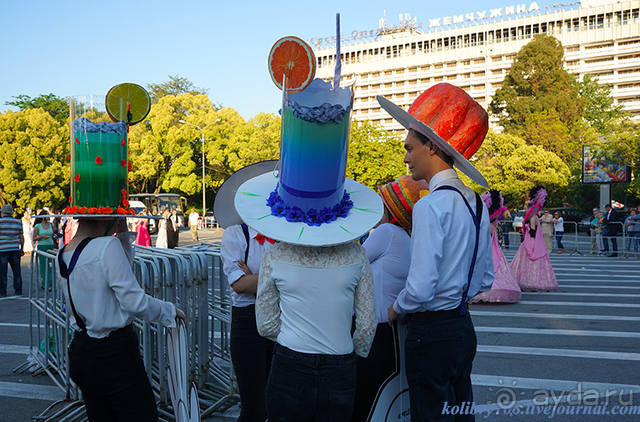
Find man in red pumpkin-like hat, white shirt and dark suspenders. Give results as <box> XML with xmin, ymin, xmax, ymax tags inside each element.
<box><xmin>378</xmin><ymin>84</ymin><xmax>494</xmax><ymax>422</ymax></box>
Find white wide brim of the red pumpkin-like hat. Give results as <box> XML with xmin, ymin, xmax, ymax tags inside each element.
<box><xmin>376</xmin><ymin>95</ymin><xmax>489</xmax><ymax>188</ymax></box>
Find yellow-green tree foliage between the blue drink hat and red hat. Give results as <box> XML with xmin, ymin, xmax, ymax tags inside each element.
<box><xmin>347</xmin><ymin>121</ymin><xmax>406</xmax><ymax>191</ymax></box>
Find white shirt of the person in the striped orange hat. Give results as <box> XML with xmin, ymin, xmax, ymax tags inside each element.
<box><xmin>362</xmin><ymin>223</ymin><xmax>411</xmax><ymax>323</ymax></box>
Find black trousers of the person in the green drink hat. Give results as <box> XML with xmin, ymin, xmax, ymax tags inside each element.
<box><xmin>69</xmin><ymin>325</ymin><xmax>158</xmax><ymax>422</ymax></box>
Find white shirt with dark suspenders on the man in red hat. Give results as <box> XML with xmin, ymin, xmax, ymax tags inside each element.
<box><xmin>393</xmin><ymin>169</ymin><xmax>494</xmax><ymax>313</ymax></box>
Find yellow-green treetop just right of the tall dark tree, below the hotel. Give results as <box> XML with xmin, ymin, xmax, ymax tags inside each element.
<box><xmin>578</xmin><ymin>74</ymin><xmax>624</xmax><ymax>135</ymax></box>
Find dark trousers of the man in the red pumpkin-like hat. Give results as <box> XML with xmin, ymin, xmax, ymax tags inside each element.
<box><xmin>405</xmin><ymin>310</ymin><xmax>477</xmax><ymax>422</ymax></box>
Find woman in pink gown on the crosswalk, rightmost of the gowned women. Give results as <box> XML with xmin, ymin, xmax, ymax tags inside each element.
<box><xmin>511</xmin><ymin>186</ymin><xmax>558</xmax><ymax>292</ymax></box>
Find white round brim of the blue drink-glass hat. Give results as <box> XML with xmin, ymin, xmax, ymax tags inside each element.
<box><xmin>235</xmin><ymin>172</ymin><xmax>383</xmax><ymax>246</ymax></box>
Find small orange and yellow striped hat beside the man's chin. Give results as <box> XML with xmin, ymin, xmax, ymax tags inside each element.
<box><xmin>380</xmin><ymin>176</ymin><xmax>429</xmax><ymax>231</ymax></box>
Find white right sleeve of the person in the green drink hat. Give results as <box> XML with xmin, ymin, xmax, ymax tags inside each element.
<box><xmin>101</xmin><ymin>237</ymin><xmax>176</xmax><ymax>327</ymax></box>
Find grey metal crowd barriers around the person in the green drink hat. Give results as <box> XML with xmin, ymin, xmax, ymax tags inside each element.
<box><xmin>14</xmin><ymin>239</ymin><xmax>238</xmax><ymax>422</ymax></box>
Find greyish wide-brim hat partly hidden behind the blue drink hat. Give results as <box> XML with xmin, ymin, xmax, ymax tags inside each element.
<box><xmin>213</xmin><ymin>160</ymin><xmax>278</xmax><ymax>229</ymax></box>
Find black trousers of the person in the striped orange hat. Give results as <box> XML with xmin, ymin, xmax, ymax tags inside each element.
<box><xmin>351</xmin><ymin>322</ymin><xmax>396</xmax><ymax>422</ymax></box>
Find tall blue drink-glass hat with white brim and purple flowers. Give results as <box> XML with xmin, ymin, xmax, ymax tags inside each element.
<box><xmin>235</xmin><ymin>17</ymin><xmax>383</xmax><ymax>246</ymax></box>
